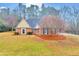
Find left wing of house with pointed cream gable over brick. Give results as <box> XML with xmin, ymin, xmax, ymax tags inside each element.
<box><xmin>16</xmin><ymin>18</ymin><xmax>32</xmax><ymax>34</ymax></box>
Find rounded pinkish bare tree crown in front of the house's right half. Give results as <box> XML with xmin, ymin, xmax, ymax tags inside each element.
<box><xmin>39</xmin><ymin>15</ymin><xmax>65</xmax><ymax>33</ymax></box>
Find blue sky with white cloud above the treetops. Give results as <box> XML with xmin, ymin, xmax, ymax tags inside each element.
<box><xmin>0</xmin><ymin>3</ymin><xmax>79</xmax><ymax>9</ymax></box>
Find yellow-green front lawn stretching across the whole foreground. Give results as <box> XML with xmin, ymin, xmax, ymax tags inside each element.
<box><xmin>0</xmin><ymin>32</ymin><xmax>79</xmax><ymax>56</ymax></box>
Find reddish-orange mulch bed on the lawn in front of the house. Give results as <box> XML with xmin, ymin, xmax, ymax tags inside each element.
<box><xmin>36</xmin><ymin>34</ymin><xmax>66</xmax><ymax>40</ymax></box>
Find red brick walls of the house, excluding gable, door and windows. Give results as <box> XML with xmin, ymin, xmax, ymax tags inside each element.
<box><xmin>16</xmin><ymin>28</ymin><xmax>63</xmax><ymax>35</ymax></box>
